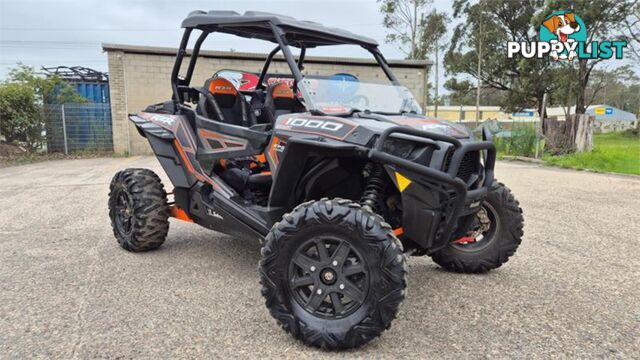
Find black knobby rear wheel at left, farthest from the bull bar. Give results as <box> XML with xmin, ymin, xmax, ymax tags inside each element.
<box><xmin>109</xmin><ymin>169</ymin><xmax>169</xmax><ymax>252</ymax></box>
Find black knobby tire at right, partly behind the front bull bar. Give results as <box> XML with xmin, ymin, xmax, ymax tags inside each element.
<box><xmin>431</xmin><ymin>183</ymin><xmax>524</xmax><ymax>273</ymax></box>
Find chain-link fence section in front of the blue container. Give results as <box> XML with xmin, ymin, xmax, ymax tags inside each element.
<box><xmin>42</xmin><ymin>103</ymin><xmax>113</xmax><ymax>154</ymax></box>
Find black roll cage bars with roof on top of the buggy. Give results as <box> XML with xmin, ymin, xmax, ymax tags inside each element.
<box><xmin>171</xmin><ymin>11</ymin><xmax>400</xmax><ymax>108</ymax></box>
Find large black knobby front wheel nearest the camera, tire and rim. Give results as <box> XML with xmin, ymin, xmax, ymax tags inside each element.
<box><xmin>260</xmin><ymin>199</ymin><xmax>406</xmax><ymax>350</ymax></box>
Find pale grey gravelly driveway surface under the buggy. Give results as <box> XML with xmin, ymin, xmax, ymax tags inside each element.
<box><xmin>0</xmin><ymin>157</ymin><xmax>640</xmax><ymax>358</ymax></box>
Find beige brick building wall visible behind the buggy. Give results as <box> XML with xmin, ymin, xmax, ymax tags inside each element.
<box><xmin>104</xmin><ymin>45</ymin><xmax>429</xmax><ymax>155</ymax></box>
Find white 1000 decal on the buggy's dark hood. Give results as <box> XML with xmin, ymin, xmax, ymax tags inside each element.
<box><xmin>276</xmin><ymin>116</ymin><xmax>358</xmax><ymax>140</ymax></box>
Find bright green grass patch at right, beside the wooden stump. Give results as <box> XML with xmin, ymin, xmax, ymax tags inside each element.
<box><xmin>543</xmin><ymin>133</ymin><xmax>640</xmax><ymax>175</ymax></box>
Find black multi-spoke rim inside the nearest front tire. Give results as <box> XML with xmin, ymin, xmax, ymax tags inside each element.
<box><xmin>288</xmin><ymin>236</ymin><xmax>369</xmax><ymax>319</ymax></box>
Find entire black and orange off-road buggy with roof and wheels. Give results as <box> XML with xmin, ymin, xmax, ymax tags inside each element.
<box><xmin>109</xmin><ymin>11</ymin><xmax>523</xmax><ymax>349</ymax></box>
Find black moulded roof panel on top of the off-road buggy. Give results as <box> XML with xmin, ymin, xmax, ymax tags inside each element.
<box><xmin>182</xmin><ymin>10</ymin><xmax>378</xmax><ymax>47</ymax></box>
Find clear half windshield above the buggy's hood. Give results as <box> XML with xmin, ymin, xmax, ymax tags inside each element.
<box><xmin>299</xmin><ymin>74</ymin><xmax>422</xmax><ymax>114</ymax></box>
